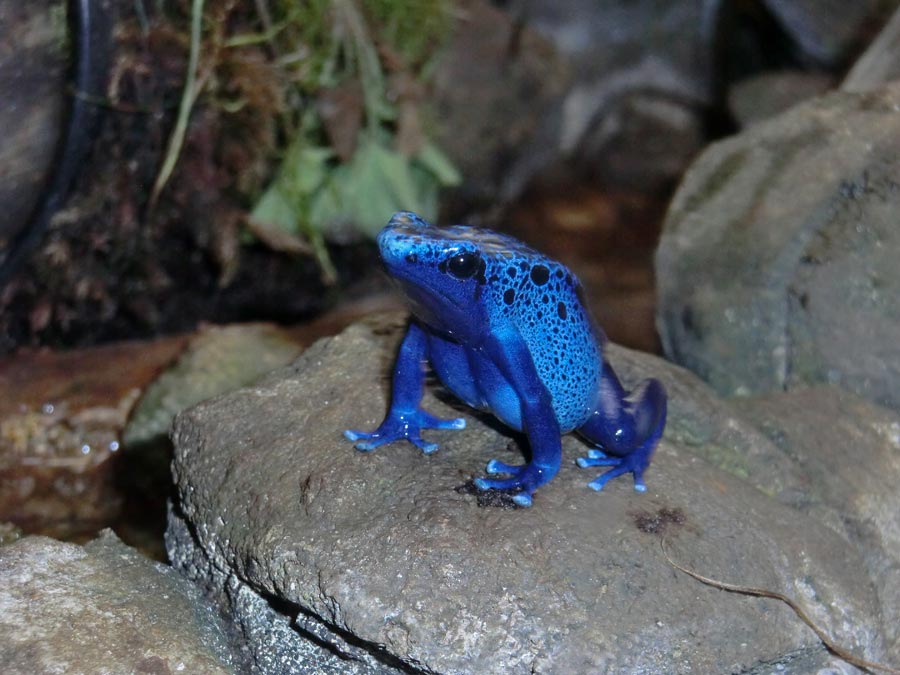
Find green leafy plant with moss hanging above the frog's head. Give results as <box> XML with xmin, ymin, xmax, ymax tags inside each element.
<box><xmin>250</xmin><ymin>0</ymin><xmax>459</xmax><ymax>278</ymax></box>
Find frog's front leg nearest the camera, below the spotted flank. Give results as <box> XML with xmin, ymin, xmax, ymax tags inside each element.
<box><xmin>475</xmin><ymin>328</ymin><xmax>562</xmax><ymax>506</ymax></box>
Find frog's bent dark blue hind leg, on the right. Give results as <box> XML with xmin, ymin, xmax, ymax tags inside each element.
<box><xmin>577</xmin><ymin>363</ymin><xmax>666</xmax><ymax>492</ymax></box>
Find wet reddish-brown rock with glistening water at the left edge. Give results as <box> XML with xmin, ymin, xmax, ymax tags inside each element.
<box><xmin>0</xmin><ymin>338</ymin><xmax>185</xmax><ymax>557</ymax></box>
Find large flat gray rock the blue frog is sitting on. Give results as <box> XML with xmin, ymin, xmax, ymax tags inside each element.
<box><xmin>169</xmin><ymin>325</ymin><xmax>897</xmax><ymax>673</ymax></box>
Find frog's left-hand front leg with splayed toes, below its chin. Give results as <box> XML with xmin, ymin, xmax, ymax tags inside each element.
<box><xmin>344</xmin><ymin>322</ymin><xmax>466</xmax><ymax>453</ymax></box>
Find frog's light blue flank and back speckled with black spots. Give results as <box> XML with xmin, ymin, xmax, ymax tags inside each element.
<box><xmin>478</xmin><ymin>234</ymin><xmax>605</xmax><ymax>431</ymax></box>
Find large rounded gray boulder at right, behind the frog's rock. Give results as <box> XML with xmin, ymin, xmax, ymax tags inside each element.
<box><xmin>656</xmin><ymin>85</ymin><xmax>900</xmax><ymax>409</ymax></box>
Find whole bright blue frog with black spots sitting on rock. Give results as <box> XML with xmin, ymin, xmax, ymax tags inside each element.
<box><xmin>344</xmin><ymin>212</ymin><xmax>666</xmax><ymax>506</ymax></box>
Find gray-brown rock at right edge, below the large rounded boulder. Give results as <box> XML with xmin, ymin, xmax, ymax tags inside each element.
<box><xmin>734</xmin><ymin>386</ymin><xmax>900</xmax><ymax>663</ymax></box>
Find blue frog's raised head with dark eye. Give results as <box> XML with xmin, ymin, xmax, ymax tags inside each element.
<box><xmin>378</xmin><ymin>211</ymin><xmax>496</xmax><ymax>339</ymax></box>
